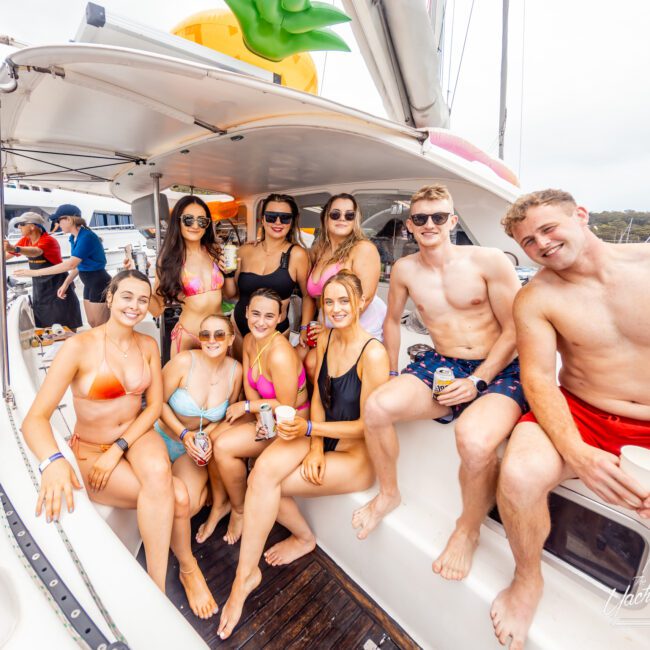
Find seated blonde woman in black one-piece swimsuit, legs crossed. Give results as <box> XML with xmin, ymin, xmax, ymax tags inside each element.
<box><xmin>219</xmin><ymin>271</ymin><xmax>389</xmax><ymax>639</ymax></box>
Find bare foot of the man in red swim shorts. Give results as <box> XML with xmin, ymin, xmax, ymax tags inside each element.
<box><xmin>490</xmin><ymin>577</ymin><xmax>544</xmax><ymax>650</ymax></box>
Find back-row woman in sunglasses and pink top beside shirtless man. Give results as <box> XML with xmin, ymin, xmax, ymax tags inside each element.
<box><xmin>305</xmin><ymin>194</ymin><xmax>386</xmax><ymax>380</ymax></box>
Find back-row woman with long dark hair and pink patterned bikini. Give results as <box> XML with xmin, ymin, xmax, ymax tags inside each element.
<box><xmin>150</xmin><ymin>196</ymin><xmax>237</xmax><ymax>357</ymax></box>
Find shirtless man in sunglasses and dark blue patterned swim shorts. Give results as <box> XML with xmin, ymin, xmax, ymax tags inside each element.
<box><xmin>352</xmin><ymin>185</ymin><xmax>525</xmax><ymax>580</ymax></box>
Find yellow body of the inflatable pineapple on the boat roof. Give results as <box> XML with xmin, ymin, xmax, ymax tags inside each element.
<box><xmin>171</xmin><ymin>9</ymin><xmax>318</xmax><ymax>95</ymax></box>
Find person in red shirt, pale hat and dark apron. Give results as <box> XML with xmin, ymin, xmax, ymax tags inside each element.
<box><xmin>4</xmin><ymin>212</ymin><xmax>82</xmax><ymax>330</ymax></box>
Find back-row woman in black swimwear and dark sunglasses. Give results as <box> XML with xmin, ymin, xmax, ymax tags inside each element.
<box><xmin>234</xmin><ymin>194</ymin><xmax>316</xmax><ymax>345</ymax></box>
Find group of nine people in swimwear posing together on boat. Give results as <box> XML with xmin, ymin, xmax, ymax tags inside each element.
<box><xmin>17</xmin><ymin>185</ymin><xmax>650</xmax><ymax>648</ymax></box>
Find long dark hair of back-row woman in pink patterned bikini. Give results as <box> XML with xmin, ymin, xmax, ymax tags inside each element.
<box><xmin>156</xmin><ymin>195</ymin><xmax>221</xmax><ymax>303</ymax></box>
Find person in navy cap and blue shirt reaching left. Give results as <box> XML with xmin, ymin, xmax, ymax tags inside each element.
<box><xmin>14</xmin><ymin>203</ymin><xmax>111</xmax><ymax>327</ymax></box>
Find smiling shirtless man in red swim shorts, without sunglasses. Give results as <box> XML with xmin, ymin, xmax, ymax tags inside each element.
<box><xmin>491</xmin><ymin>190</ymin><xmax>650</xmax><ymax>650</ymax></box>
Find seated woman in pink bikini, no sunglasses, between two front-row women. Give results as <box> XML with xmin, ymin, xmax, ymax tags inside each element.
<box><xmin>212</xmin><ymin>289</ymin><xmax>309</xmax><ymax>544</ymax></box>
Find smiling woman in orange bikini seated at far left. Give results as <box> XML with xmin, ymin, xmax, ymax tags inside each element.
<box><xmin>22</xmin><ymin>271</ymin><xmax>174</xmax><ymax>591</ymax></box>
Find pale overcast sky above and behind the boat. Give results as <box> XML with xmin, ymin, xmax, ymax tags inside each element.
<box><xmin>0</xmin><ymin>0</ymin><xmax>650</xmax><ymax>211</ymax></box>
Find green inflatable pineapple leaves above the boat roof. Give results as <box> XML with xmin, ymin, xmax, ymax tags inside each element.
<box><xmin>226</xmin><ymin>0</ymin><xmax>350</xmax><ymax>61</ymax></box>
